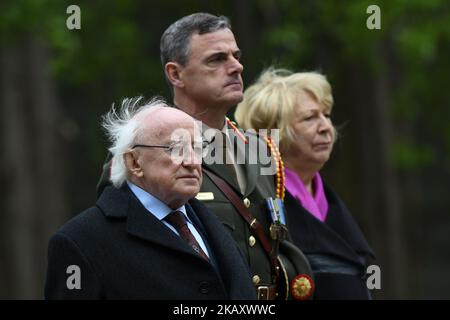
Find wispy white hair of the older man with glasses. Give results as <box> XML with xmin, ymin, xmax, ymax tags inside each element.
<box><xmin>102</xmin><ymin>96</ymin><xmax>167</xmax><ymax>188</ymax></box>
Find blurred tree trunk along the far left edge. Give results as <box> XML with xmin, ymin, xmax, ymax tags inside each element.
<box><xmin>1</xmin><ymin>43</ymin><xmax>38</xmax><ymax>299</ymax></box>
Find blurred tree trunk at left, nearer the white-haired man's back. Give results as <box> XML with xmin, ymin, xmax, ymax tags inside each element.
<box><xmin>28</xmin><ymin>35</ymin><xmax>68</xmax><ymax>298</ymax></box>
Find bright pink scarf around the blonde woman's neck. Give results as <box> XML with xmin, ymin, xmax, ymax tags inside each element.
<box><xmin>284</xmin><ymin>168</ymin><xmax>328</xmax><ymax>222</ymax></box>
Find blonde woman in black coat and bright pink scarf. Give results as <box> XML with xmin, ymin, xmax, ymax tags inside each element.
<box><xmin>235</xmin><ymin>69</ymin><xmax>373</xmax><ymax>299</ymax></box>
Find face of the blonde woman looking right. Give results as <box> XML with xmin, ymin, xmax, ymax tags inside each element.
<box><xmin>285</xmin><ymin>91</ymin><xmax>335</xmax><ymax>171</ymax></box>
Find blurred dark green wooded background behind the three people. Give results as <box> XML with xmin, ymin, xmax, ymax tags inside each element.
<box><xmin>0</xmin><ymin>0</ymin><xmax>450</xmax><ymax>299</ymax></box>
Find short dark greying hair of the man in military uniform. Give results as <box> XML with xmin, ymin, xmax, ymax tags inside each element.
<box><xmin>159</xmin><ymin>12</ymin><xmax>231</xmax><ymax>68</ymax></box>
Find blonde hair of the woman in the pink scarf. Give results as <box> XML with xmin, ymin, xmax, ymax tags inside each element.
<box><xmin>234</xmin><ymin>68</ymin><xmax>333</xmax><ymax>149</ymax></box>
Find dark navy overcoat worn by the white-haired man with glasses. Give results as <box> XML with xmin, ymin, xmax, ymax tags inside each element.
<box><xmin>45</xmin><ymin>185</ymin><xmax>256</xmax><ymax>299</ymax></box>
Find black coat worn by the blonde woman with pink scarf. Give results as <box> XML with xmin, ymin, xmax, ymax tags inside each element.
<box><xmin>284</xmin><ymin>184</ymin><xmax>374</xmax><ymax>299</ymax></box>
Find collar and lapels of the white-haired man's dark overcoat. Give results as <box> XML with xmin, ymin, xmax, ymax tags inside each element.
<box><xmin>96</xmin><ymin>185</ymin><xmax>254</xmax><ymax>299</ymax></box>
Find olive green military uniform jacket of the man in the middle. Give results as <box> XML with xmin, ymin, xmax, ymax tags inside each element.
<box><xmin>197</xmin><ymin>125</ymin><xmax>311</xmax><ymax>298</ymax></box>
